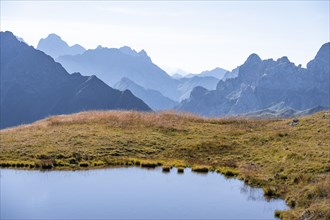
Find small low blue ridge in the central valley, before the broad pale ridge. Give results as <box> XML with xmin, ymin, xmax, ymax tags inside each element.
<box><xmin>114</xmin><ymin>77</ymin><xmax>179</xmax><ymax>111</ymax></box>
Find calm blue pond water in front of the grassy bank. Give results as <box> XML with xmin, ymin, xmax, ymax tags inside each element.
<box><xmin>0</xmin><ymin>167</ymin><xmax>287</xmax><ymax>219</ymax></box>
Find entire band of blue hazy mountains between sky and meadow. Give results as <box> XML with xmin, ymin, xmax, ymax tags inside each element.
<box><xmin>0</xmin><ymin>32</ymin><xmax>330</xmax><ymax>128</ymax></box>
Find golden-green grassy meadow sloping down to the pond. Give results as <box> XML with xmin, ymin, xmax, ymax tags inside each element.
<box><xmin>0</xmin><ymin>111</ymin><xmax>330</xmax><ymax>219</ymax></box>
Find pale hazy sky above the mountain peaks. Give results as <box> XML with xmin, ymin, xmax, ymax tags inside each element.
<box><xmin>0</xmin><ymin>0</ymin><xmax>330</xmax><ymax>72</ymax></box>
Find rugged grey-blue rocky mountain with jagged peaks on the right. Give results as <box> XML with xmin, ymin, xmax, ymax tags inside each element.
<box><xmin>178</xmin><ymin>43</ymin><xmax>330</xmax><ymax>116</ymax></box>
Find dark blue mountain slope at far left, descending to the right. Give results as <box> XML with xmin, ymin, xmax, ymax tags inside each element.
<box><xmin>0</xmin><ymin>32</ymin><xmax>150</xmax><ymax>128</ymax></box>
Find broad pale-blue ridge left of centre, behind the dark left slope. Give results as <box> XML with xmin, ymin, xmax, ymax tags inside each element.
<box><xmin>56</xmin><ymin>46</ymin><xmax>179</xmax><ymax>100</ymax></box>
